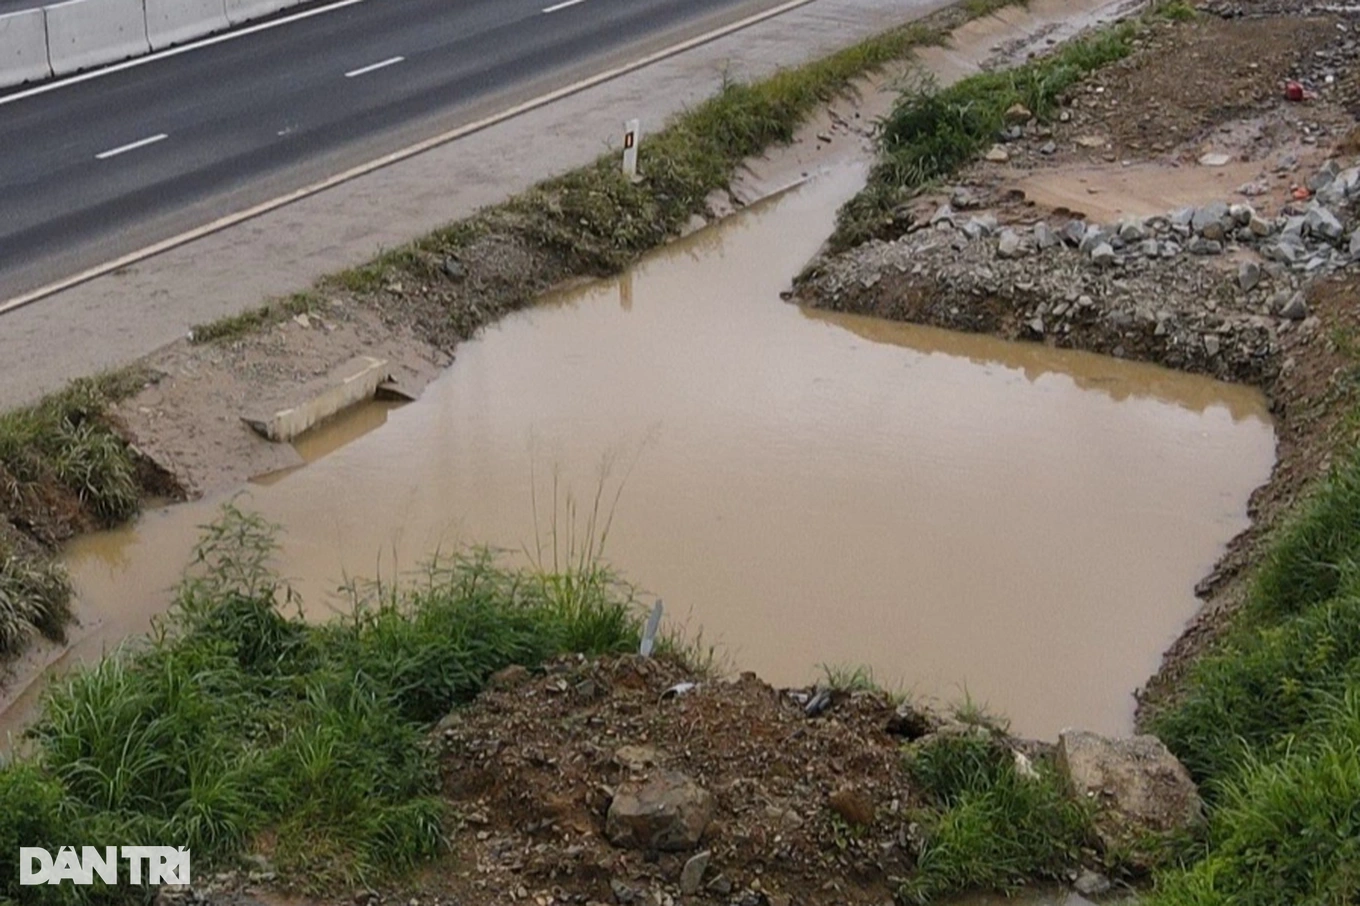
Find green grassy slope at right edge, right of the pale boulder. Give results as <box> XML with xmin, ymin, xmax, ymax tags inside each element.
<box><xmin>1151</xmin><ymin>435</ymin><xmax>1360</xmax><ymax>906</ymax></box>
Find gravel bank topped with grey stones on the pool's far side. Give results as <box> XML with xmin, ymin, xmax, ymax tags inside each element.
<box><xmin>794</xmin><ymin>162</ymin><xmax>1360</xmax><ymax>386</ymax></box>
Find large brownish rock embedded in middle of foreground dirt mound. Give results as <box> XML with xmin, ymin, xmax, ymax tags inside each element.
<box><xmin>604</xmin><ymin>771</ymin><xmax>713</xmax><ymax>852</ymax></box>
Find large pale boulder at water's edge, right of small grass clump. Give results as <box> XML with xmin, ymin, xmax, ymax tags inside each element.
<box><xmin>1057</xmin><ymin>731</ymin><xmax>1204</xmax><ymax>849</ymax></box>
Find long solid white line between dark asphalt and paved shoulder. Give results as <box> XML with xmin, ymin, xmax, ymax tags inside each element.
<box><xmin>0</xmin><ymin>0</ymin><xmax>815</xmax><ymax>314</ymax></box>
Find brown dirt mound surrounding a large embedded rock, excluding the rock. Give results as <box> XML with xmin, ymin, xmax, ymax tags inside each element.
<box><xmin>435</xmin><ymin>657</ymin><xmax>926</xmax><ymax>903</ymax></box>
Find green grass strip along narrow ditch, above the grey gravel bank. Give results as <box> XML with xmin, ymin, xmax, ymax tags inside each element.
<box><xmin>831</xmin><ymin>22</ymin><xmax>1138</xmax><ymax>250</ymax></box>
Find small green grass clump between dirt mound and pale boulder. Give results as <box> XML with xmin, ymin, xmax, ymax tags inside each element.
<box><xmin>899</xmin><ymin>729</ymin><xmax>1091</xmax><ymax>903</ymax></box>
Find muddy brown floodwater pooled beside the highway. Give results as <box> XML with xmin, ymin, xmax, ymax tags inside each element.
<box><xmin>0</xmin><ymin>170</ymin><xmax>1274</xmax><ymax>737</ymax></box>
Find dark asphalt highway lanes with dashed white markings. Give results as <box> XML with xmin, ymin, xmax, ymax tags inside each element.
<box><xmin>0</xmin><ymin>0</ymin><xmax>775</xmax><ymax>299</ymax></box>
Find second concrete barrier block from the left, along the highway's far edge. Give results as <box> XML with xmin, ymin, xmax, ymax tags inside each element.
<box><xmin>42</xmin><ymin>0</ymin><xmax>151</xmax><ymax>75</ymax></box>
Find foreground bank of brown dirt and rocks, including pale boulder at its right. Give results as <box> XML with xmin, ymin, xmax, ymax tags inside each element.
<box><xmin>167</xmin><ymin>656</ymin><xmax>1202</xmax><ymax>906</ymax></box>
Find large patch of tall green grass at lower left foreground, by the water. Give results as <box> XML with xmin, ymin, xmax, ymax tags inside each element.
<box><xmin>0</xmin><ymin>505</ymin><xmax>638</xmax><ymax>902</ymax></box>
